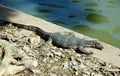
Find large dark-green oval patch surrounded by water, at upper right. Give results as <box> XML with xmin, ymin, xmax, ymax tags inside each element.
<box><xmin>86</xmin><ymin>13</ymin><xmax>110</xmax><ymax>23</ymax></box>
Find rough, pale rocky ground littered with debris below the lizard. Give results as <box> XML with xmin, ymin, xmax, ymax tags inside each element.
<box><xmin>0</xmin><ymin>21</ymin><xmax>120</xmax><ymax>76</ymax></box>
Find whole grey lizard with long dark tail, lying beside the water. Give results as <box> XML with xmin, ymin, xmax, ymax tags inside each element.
<box><xmin>0</xmin><ymin>21</ymin><xmax>103</xmax><ymax>55</ymax></box>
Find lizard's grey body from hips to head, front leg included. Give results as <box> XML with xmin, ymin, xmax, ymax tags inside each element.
<box><xmin>50</xmin><ymin>33</ymin><xmax>103</xmax><ymax>55</ymax></box>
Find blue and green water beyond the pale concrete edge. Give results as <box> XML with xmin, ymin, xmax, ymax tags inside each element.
<box><xmin>0</xmin><ymin>0</ymin><xmax>120</xmax><ymax>48</ymax></box>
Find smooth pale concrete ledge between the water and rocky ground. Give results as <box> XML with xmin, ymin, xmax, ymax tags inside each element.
<box><xmin>0</xmin><ymin>5</ymin><xmax>120</xmax><ymax>67</ymax></box>
